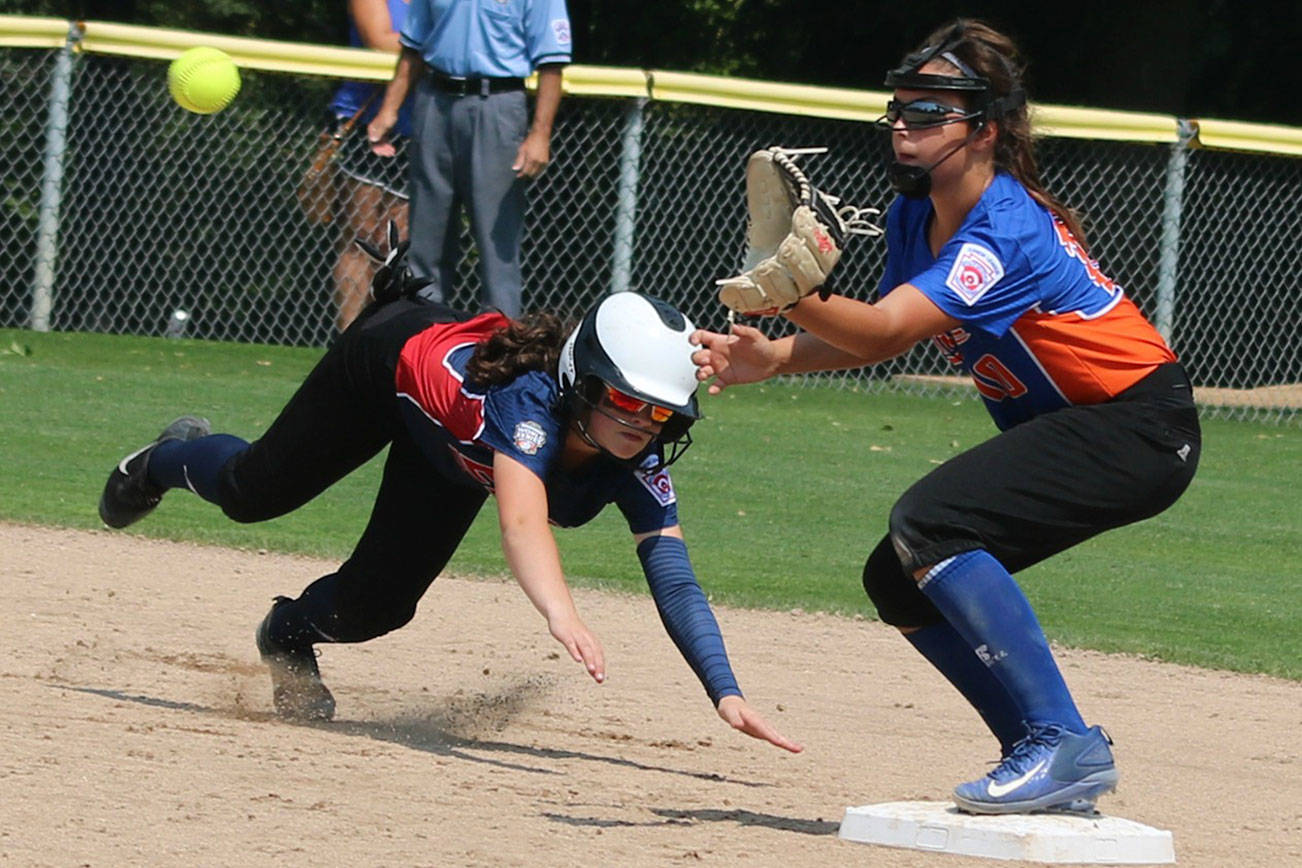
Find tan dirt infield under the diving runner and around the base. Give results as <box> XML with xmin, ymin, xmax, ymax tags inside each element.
<box><xmin>0</xmin><ymin>524</ymin><xmax>1302</xmax><ymax>868</ymax></box>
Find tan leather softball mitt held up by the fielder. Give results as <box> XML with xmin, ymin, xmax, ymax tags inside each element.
<box><xmin>716</xmin><ymin>147</ymin><xmax>881</xmax><ymax>316</ymax></box>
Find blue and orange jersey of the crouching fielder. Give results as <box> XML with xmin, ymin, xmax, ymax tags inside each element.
<box><xmin>879</xmin><ymin>172</ymin><xmax>1176</xmax><ymax>429</ymax></box>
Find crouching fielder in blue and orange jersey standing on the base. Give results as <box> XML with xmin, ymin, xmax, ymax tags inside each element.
<box><xmin>695</xmin><ymin>15</ymin><xmax>1202</xmax><ymax>815</ymax></box>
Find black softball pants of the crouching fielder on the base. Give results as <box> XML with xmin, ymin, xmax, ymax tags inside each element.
<box><xmin>863</xmin><ymin>363</ymin><xmax>1202</xmax><ymax>627</ymax></box>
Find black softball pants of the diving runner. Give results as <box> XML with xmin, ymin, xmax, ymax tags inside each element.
<box><xmin>219</xmin><ymin>301</ymin><xmax>486</xmax><ymax>642</ymax></box>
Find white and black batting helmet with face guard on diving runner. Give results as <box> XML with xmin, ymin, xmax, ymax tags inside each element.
<box><xmin>557</xmin><ymin>292</ymin><xmax>700</xmax><ymax>470</ymax></box>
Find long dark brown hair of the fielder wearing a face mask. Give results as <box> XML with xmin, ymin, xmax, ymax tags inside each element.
<box><xmin>922</xmin><ymin>18</ymin><xmax>1086</xmax><ymax>249</ymax></box>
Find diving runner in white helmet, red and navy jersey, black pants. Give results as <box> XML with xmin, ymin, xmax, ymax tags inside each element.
<box><xmin>99</xmin><ymin>269</ymin><xmax>801</xmax><ymax>752</ymax></box>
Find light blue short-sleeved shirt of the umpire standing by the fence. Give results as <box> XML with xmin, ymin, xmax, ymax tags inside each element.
<box><xmin>398</xmin><ymin>0</ymin><xmax>570</xmax><ymax>78</ymax></box>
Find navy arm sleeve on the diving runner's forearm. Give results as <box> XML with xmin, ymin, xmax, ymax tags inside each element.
<box><xmin>638</xmin><ymin>535</ymin><xmax>741</xmax><ymax>705</ymax></box>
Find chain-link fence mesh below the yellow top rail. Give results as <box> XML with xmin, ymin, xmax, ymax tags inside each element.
<box><xmin>0</xmin><ymin>33</ymin><xmax>1302</xmax><ymax>422</ymax></box>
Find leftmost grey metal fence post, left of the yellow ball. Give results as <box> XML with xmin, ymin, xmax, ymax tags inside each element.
<box><xmin>31</xmin><ymin>22</ymin><xmax>82</xmax><ymax>332</ymax></box>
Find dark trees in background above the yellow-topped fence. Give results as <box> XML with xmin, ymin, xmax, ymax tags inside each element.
<box><xmin>0</xmin><ymin>0</ymin><xmax>1302</xmax><ymax>125</ymax></box>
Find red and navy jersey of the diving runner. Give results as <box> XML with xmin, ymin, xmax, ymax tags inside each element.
<box><xmin>395</xmin><ymin>314</ymin><xmax>678</xmax><ymax>534</ymax></box>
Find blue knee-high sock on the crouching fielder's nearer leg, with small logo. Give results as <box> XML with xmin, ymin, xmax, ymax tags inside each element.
<box><xmin>919</xmin><ymin>549</ymin><xmax>1086</xmax><ymax>733</ymax></box>
